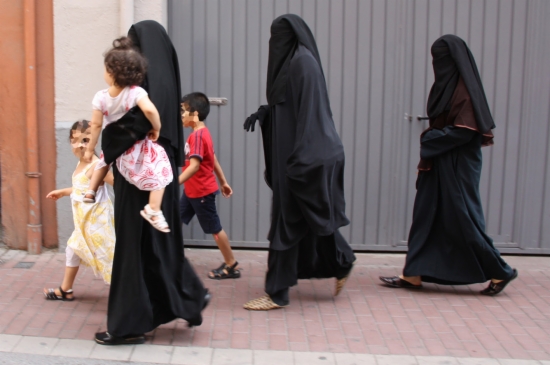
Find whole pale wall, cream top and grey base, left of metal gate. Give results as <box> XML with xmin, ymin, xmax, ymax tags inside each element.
<box><xmin>53</xmin><ymin>0</ymin><xmax>167</xmax><ymax>250</ymax></box>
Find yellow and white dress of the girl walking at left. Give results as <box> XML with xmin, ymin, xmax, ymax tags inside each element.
<box><xmin>67</xmin><ymin>164</ymin><xmax>115</xmax><ymax>284</ymax></box>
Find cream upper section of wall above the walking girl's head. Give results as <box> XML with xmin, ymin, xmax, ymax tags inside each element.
<box><xmin>54</xmin><ymin>0</ymin><xmax>167</xmax><ymax>122</ymax></box>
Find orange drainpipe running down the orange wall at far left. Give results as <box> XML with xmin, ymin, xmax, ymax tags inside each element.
<box><xmin>23</xmin><ymin>0</ymin><xmax>42</xmax><ymax>254</ymax></box>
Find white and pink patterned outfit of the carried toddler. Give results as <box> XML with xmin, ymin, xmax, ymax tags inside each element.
<box><xmin>92</xmin><ymin>86</ymin><xmax>174</xmax><ymax>191</ymax></box>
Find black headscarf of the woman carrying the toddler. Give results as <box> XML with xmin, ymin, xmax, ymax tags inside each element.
<box><xmin>128</xmin><ymin>20</ymin><xmax>184</xmax><ymax>166</ymax></box>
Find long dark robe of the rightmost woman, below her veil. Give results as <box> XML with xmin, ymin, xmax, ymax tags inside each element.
<box><xmin>403</xmin><ymin>126</ymin><xmax>512</xmax><ymax>284</ymax></box>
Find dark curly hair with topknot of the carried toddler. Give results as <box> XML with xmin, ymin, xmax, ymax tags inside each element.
<box><xmin>104</xmin><ymin>37</ymin><xmax>147</xmax><ymax>87</ymax></box>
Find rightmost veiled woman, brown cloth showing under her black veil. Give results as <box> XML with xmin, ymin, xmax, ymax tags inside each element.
<box><xmin>380</xmin><ymin>35</ymin><xmax>518</xmax><ymax>295</ymax></box>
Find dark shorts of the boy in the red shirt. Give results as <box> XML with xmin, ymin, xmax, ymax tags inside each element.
<box><xmin>180</xmin><ymin>190</ymin><xmax>222</xmax><ymax>234</ymax></box>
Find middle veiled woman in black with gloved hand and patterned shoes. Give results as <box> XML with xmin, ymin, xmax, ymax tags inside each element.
<box><xmin>244</xmin><ymin>14</ymin><xmax>355</xmax><ymax>310</ymax></box>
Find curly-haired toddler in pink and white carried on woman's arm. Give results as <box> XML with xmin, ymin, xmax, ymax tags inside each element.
<box><xmin>84</xmin><ymin>37</ymin><xmax>173</xmax><ymax>232</ymax></box>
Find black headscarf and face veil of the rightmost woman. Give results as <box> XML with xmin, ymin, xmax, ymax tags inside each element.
<box><xmin>427</xmin><ymin>34</ymin><xmax>495</xmax><ymax>133</ymax></box>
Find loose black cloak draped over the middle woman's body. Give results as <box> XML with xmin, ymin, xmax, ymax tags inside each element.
<box><xmin>268</xmin><ymin>45</ymin><xmax>349</xmax><ymax>250</ymax></box>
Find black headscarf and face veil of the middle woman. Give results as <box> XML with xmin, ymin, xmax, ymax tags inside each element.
<box><xmin>266</xmin><ymin>14</ymin><xmax>323</xmax><ymax>106</ymax></box>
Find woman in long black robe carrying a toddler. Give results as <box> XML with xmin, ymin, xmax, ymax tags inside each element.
<box><xmin>96</xmin><ymin>20</ymin><xmax>209</xmax><ymax>345</ymax></box>
